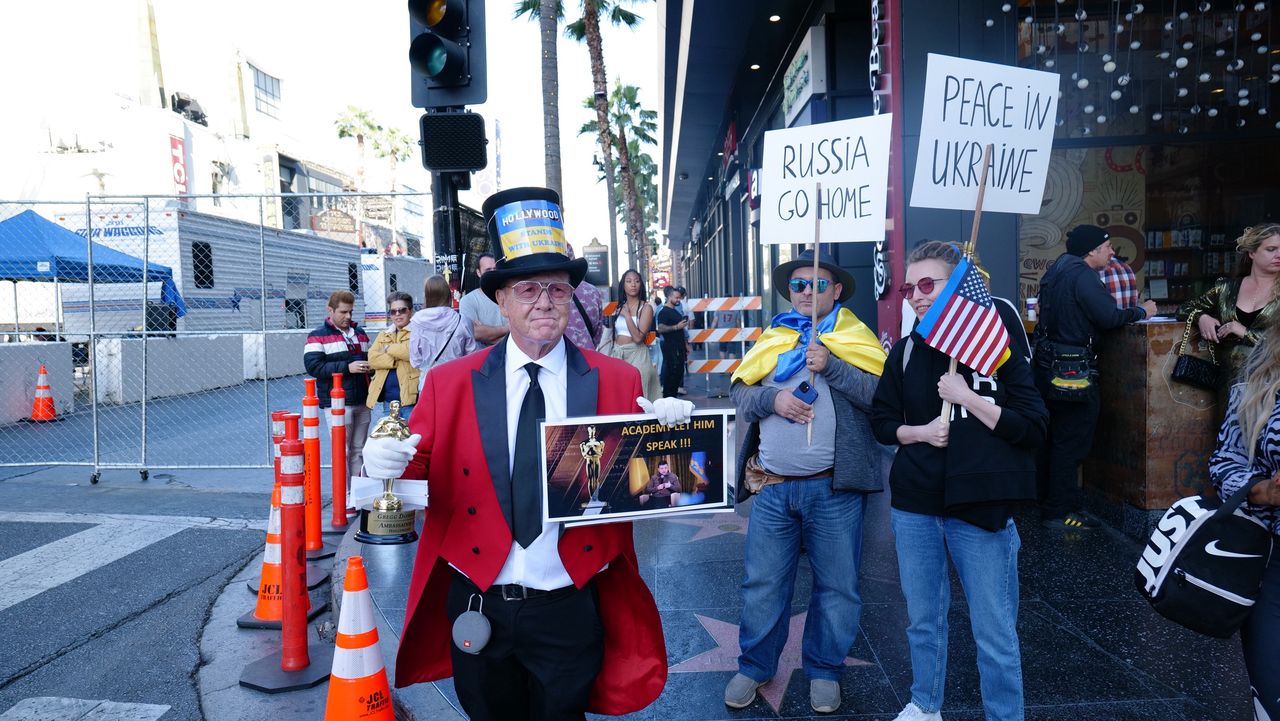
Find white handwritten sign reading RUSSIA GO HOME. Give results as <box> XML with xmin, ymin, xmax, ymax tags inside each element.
<box><xmin>760</xmin><ymin>115</ymin><xmax>893</xmax><ymax>245</ymax></box>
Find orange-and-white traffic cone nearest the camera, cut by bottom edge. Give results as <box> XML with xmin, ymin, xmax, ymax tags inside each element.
<box><xmin>324</xmin><ymin>556</ymin><xmax>396</xmax><ymax>721</ymax></box>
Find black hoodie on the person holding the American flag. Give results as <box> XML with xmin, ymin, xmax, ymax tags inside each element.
<box><xmin>872</xmin><ymin>302</ymin><xmax>1048</xmax><ymax>530</ymax></box>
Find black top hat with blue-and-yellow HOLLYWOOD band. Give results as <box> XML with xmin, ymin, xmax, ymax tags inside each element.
<box><xmin>480</xmin><ymin>187</ymin><xmax>586</xmax><ymax>301</ymax></box>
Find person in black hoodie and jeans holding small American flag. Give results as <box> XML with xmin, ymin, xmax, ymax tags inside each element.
<box><xmin>872</xmin><ymin>241</ymin><xmax>1048</xmax><ymax>721</ymax></box>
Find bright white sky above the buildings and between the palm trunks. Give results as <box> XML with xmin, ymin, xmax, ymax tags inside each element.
<box><xmin>0</xmin><ymin>0</ymin><xmax>660</xmax><ymax>272</ymax></box>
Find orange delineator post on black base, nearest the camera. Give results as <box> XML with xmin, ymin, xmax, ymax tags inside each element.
<box><xmin>239</xmin><ymin>427</ymin><xmax>333</xmax><ymax>693</ymax></box>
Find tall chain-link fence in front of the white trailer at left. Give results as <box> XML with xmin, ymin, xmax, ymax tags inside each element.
<box><xmin>0</xmin><ymin>193</ymin><xmax>434</xmax><ymax>482</ymax></box>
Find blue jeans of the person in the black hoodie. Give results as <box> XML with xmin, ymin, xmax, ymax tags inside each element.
<box><xmin>890</xmin><ymin>508</ymin><xmax>1023</xmax><ymax>721</ymax></box>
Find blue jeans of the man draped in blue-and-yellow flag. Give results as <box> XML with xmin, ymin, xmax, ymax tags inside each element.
<box><xmin>737</xmin><ymin>478</ymin><xmax>867</xmax><ymax>683</ymax></box>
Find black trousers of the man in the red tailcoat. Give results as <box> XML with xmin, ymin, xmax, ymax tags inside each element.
<box><xmin>447</xmin><ymin>575</ymin><xmax>604</xmax><ymax>721</ymax></box>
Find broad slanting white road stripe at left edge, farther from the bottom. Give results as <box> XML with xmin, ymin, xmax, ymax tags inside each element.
<box><xmin>0</xmin><ymin>523</ymin><xmax>191</xmax><ymax>611</ymax></box>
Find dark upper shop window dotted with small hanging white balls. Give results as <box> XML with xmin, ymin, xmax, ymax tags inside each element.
<box><xmin>1013</xmin><ymin>0</ymin><xmax>1280</xmax><ymax>138</ymax></box>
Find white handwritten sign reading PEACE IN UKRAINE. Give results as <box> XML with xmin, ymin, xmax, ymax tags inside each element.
<box><xmin>911</xmin><ymin>53</ymin><xmax>1059</xmax><ymax>215</ymax></box>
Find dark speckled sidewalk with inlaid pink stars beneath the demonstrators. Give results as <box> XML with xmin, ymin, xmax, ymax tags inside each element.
<box><xmin>198</xmin><ymin>384</ymin><xmax>1252</xmax><ymax>721</ymax></box>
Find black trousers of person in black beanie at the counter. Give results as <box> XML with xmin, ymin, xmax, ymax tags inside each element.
<box><xmin>1041</xmin><ymin>393</ymin><xmax>1101</xmax><ymax>519</ymax></box>
